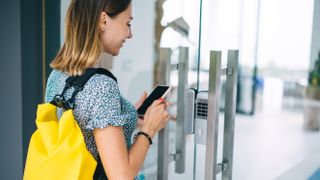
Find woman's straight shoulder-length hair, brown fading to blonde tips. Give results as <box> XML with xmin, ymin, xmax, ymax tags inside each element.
<box><xmin>50</xmin><ymin>0</ymin><xmax>131</xmax><ymax>76</ymax></box>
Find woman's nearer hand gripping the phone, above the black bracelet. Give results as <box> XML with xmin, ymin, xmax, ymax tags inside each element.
<box><xmin>141</xmin><ymin>98</ymin><xmax>169</xmax><ymax>138</ymax></box>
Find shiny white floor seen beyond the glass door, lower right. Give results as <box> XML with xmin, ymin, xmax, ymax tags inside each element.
<box><xmin>233</xmin><ymin>108</ymin><xmax>320</xmax><ymax>180</ymax></box>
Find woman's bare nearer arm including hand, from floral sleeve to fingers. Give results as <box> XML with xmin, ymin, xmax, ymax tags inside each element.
<box><xmin>94</xmin><ymin>99</ymin><xmax>168</xmax><ymax>180</ymax></box>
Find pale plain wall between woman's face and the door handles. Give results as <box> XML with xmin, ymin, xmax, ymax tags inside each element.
<box><xmin>113</xmin><ymin>0</ymin><xmax>155</xmax><ymax>102</ymax></box>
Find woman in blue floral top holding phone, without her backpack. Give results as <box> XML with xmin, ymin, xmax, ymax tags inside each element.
<box><xmin>46</xmin><ymin>0</ymin><xmax>168</xmax><ymax>180</ymax></box>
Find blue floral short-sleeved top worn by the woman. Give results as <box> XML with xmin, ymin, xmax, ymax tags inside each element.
<box><xmin>45</xmin><ymin>70</ymin><xmax>137</xmax><ymax>160</ymax></box>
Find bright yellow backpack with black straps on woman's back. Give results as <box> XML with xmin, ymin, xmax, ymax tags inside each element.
<box><xmin>23</xmin><ymin>68</ymin><xmax>116</xmax><ymax>180</ymax></box>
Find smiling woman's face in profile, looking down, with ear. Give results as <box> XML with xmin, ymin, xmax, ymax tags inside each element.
<box><xmin>100</xmin><ymin>4</ymin><xmax>132</xmax><ymax>56</ymax></box>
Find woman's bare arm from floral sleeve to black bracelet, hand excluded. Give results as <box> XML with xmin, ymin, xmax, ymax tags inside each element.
<box><xmin>94</xmin><ymin>126</ymin><xmax>154</xmax><ymax>180</ymax></box>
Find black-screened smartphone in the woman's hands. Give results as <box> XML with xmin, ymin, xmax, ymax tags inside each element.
<box><xmin>137</xmin><ymin>85</ymin><xmax>171</xmax><ymax>117</ymax></box>
